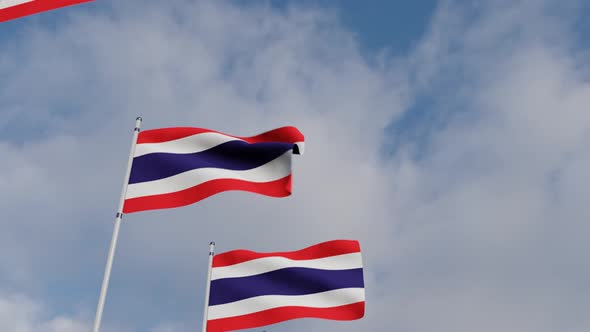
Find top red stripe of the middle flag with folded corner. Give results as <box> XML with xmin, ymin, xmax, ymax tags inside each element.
<box><xmin>137</xmin><ymin>126</ymin><xmax>304</xmax><ymax>144</ymax></box>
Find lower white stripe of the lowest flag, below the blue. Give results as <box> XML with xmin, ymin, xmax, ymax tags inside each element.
<box><xmin>208</xmin><ymin>288</ymin><xmax>365</xmax><ymax>320</ymax></box>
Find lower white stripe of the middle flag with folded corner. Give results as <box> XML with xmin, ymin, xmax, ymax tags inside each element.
<box><xmin>126</xmin><ymin>151</ymin><xmax>292</xmax><ymax>199</ymax></box>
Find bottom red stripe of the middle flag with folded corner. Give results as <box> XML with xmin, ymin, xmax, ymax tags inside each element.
<box><xmin>123</xmin><ymin>175</ymin><xmax>291</xmax><ymax>213</ymax></box>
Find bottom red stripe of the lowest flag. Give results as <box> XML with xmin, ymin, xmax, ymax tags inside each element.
<box><xmin>207</xmin><ymin>301</ymin><xmax>365</xmax><ymax>332</ymax></box>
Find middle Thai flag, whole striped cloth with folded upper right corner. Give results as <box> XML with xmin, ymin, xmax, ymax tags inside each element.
<box><xmin>123</xmin><ymin>127</ymin><xmax>304</xmax><ymax>213</ymax></box>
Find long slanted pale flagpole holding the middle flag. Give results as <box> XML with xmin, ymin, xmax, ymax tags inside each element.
<box><xmin>92</xmin><ymin>117</ymin><xmax>142</xmax><ymax>332</ymax></box>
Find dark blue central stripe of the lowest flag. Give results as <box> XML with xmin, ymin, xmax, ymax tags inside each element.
<box><xmin>209</xmin><ymin>267</ymin><xmax>364</xmax><ymax>305</ymax></box>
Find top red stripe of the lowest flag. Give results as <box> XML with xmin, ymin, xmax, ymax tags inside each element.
<box><xmin>213</xmin><ymin>240</ymin><xmax>361</xmax><ymax>267</ymax></box>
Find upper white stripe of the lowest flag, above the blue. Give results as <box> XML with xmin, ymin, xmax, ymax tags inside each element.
<box><xmin>211</xmin><ymin>252</ymin><xmax>363</xmax><ymax>280</ymax></box>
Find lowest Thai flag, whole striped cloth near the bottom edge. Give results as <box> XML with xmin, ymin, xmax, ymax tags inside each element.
<box><xmin>207</xmin><ymin>240</ymin><xmax>365</xmax><ymax>332</ymax></box>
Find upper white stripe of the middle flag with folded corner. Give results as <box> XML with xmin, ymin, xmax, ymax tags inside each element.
<box><xmin>135</xmin><ymin>132</ymin><xmax>242</xmax><ymax>157</ymax></box>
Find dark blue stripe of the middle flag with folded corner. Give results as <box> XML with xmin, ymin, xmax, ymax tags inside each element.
<box><xmin>129</xmin><ymin>140</ymin><xmax>293</xmax><ymax>184</ymax></box>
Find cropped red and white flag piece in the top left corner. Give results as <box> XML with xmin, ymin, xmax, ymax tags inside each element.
<box><xmin>0</xmin><ymin>0</ymin><xmax>93</xmax><ymax>22</ymax></box>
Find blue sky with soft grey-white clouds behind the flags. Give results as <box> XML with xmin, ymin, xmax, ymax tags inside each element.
<box><xmin>0</xmin><ymin>0</ymin><xmax>590</xmax><ymax>332</ymax></box>
